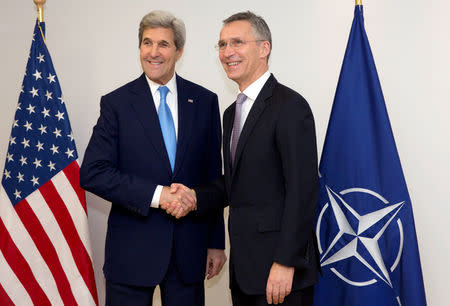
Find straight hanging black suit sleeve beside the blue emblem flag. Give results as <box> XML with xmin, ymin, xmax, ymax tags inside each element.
<box><xmin>274</xmin><ymin>97</ymin><xmax>318</xmax><ymax>267</ymax></box>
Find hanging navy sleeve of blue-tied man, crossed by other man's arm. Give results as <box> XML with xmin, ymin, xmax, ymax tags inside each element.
<box><xmin>208</xmin><ymin>95</ymin><xmax>225</xmax><ymax>249</ymax></box>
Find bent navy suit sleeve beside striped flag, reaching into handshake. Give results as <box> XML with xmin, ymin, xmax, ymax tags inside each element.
<box><xmin>80</xmin><ymin>96</ymin><xmax>156</xmax><ymax>216</ymax></box>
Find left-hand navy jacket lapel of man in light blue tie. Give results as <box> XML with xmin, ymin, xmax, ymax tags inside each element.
<box><xmin>130</xmin><ymin>74</ymin><xmax>172</xmax><ymax>174</ymax></box>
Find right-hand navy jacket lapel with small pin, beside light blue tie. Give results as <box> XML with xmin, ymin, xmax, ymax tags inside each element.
<box><xmin>174</xmin><ymin>75</ymin><xmax>196</xmax><ymax>175</ymax></box>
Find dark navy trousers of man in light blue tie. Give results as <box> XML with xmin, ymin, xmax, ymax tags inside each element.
<box><xmin>106</xmin><ymin>251</ymin><xmax>205</xmax><ymax>306</ymax></box>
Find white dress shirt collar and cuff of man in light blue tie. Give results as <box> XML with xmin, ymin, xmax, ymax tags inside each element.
<box><xmin>145</xmin><ymin>73</ymin><xmax>178</xmax><ymax>208</ymax></box>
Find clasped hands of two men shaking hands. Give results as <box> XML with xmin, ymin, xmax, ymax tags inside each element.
<box><xmin>159</xmin><ymin>183</ymin><xmax>197</xmax><ymax>219</ymax></box>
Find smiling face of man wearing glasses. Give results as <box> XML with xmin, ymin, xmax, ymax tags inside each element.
<box><xmin>219</xmin><ymin>20</ymin><xmax>270</xmax><ymax>91</ymax></box>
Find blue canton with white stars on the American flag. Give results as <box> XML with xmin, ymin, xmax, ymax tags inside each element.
<box><xmin>2</xmin><ymin>22</ymin><xmax>78</xmax><ymax>206</ymax></box>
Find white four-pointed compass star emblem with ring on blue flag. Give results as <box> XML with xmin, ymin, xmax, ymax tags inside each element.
<box><xmin>316</xmin><ymin>186</ymin><xmax>405</xmax><ymax>288</ymax></box>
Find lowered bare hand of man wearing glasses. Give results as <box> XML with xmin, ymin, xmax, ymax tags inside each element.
<box><xmin>266</xmin><ymin>262</ymin><xmax>294</xmax><ymax>304</ymax></box>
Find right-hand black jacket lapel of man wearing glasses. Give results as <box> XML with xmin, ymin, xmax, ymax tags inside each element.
<box><xmin>232</xmin><ymin>74</ymin><xmax>277</xmax><ymax>177</ymax></box>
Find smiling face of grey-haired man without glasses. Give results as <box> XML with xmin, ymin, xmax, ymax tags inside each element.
<box><xmin>139</xmin><ymin>28</ymin><xmax>183</xmax><ymax>85</ymax></box>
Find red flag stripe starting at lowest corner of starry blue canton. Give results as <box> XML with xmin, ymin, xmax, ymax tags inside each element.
<box><xmin>16</xmin><ymin>195</ymin><xmax>76</xmax><ymax>305</ymax></box>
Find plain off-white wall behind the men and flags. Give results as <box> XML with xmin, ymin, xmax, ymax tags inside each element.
<box><xmin>0</xmin><ymin>0</ymin><xmax>450</xmax><ymax>306</ymax></box>
